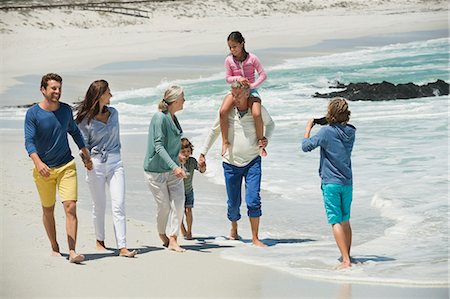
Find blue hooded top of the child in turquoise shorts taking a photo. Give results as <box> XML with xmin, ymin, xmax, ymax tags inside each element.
<box><xmin>302</xmin><ymin>124</ymin><xmax>356</xmax><ymax>185</ymax></box>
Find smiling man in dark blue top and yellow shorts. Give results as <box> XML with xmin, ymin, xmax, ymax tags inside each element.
<box><xmin>25</xmin><ymin>73</ymin><xmax>92</xmax><ymax>263</ymax></box>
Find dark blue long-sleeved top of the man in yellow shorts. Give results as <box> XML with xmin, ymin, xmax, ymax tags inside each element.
<box><xmin>24</xmin><ymin>103</ymin><xmax>85</xmax><ymax>167</ymax></box>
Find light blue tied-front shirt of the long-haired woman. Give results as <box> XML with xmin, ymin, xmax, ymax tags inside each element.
<box><xmin>78</xmin><ymin>107</ymin><xmax>121</xmax><ymax>163</ymax></box>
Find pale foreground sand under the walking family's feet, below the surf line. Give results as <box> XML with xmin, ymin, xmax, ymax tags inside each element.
<box><xmin>0</xmin><ymin>130</ymin><xmax>448</xmax><ymax>298</ymax></box>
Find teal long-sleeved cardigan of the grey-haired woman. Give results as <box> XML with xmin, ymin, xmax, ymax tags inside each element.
<box><xmin>144</xmin><ymin>112</ymin><xmax>183</xmax><ymax>173</ymax></box>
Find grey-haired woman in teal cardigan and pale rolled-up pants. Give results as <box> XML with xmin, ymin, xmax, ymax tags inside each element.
<box><xmin>144</xmin><ymin>86</ymin><xmax>186</xmax><ymax>252</ymax></box>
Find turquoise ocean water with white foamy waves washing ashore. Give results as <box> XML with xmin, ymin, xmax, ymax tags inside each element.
<box><xmin>0</xmin><ymin>38</ymin><xmax>450</xmax><ymax>287</ymax></box>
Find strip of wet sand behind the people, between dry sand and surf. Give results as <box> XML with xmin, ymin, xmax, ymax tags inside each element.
<box><xmin>0</xmin><ymin>29</ymin><xmax>449</xmax><ymax>108</ymax></box>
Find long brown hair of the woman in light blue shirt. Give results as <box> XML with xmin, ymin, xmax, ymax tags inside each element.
<box><xmin>75</xmin><ymin>80</ymin><xmax>109</xmax><ymax>124</ymax></box>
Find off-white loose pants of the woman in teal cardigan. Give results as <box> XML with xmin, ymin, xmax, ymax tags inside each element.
<box><xmin>145</xmin><ymin>171</ymin><xmax>184</xmax><ymax>237</ymax></box>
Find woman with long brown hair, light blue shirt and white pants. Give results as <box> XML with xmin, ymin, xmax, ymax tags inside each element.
<box><xmin>76</xmin><ymin>80</ymin><xmax>136</xmax><ymax>257</ymax></box>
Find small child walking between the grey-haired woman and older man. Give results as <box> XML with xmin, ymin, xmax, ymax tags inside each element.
<box><xmin>180</xmin><ymin>138</ymin><xmax>206</xmax><ymax>240</ymax></box>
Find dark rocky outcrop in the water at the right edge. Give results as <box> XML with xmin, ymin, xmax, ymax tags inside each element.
<box><xmin>313</xmin><ymin>80</ymin><xmax>449</xmax><ymax>101</ymax></box>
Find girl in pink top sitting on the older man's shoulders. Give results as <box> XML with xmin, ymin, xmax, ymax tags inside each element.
<box><xmin>220</xmin><ymin>31</ymin><xmax>267</xmax><ymax>156</ymax></box>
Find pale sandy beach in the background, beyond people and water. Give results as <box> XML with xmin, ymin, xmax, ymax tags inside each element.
<box><xmin>0</xmin><ymin>8</ymin><xmax>448</xmax><ymax>106</ymax></box>
